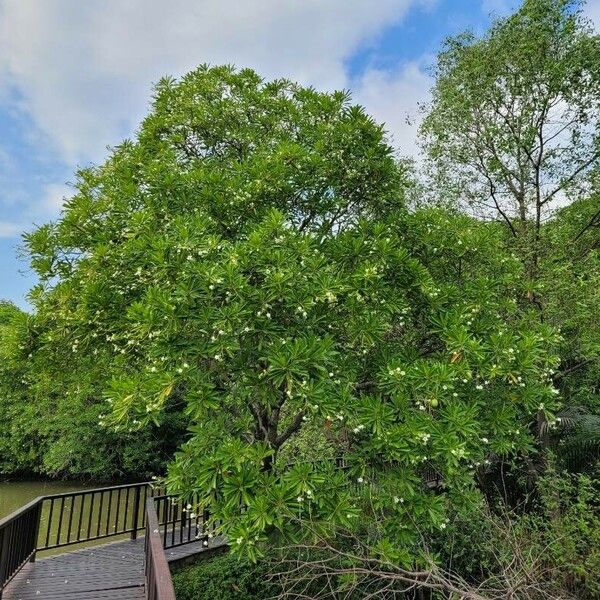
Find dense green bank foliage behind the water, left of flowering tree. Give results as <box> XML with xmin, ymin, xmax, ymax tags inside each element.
<box><xmin>0</xmin><ymin>298</ymin><xmax>182</xmax><ymax>480</ymax></box>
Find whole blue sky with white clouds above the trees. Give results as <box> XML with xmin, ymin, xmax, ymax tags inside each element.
<box><xmin>0</xmin><ymin>0</ymin><xmax>600</xmax><ymax>308</ymax></box>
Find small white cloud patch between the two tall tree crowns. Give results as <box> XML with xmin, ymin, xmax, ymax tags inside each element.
<box><xmin>354</xmin><ymin>62</ymin><xmax>433</xmax><ymax>156</ymax></box>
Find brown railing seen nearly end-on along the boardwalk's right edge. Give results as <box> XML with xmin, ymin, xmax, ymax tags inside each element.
<box><xmin>144</xmin><ymin>498</ymin><xmax>175</xmax><ymax>600</ymax></box>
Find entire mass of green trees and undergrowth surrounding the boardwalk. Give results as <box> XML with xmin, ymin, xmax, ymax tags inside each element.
<box><xmin>0</xmin><ymin>0</ymin><xmax>600</xmax><ymax>598</ymax></box>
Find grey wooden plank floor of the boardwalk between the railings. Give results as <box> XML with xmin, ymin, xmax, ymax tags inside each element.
<box><xmin>2</xmin><ymin>537</ymin><xmax>224</xmax><ymax>600</ymax></box>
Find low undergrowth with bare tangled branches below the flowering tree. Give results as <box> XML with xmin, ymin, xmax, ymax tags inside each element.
<box><xmin>272</xmin><ymin>468</ymin><xmax>600</xmax><ymax>600</ymax></box>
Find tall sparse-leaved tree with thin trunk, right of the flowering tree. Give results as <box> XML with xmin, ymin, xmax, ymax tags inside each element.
<box><xmin>422</xmin><ymin>0</ymin><xmax>600</xmax><ymax>290</ymax></box>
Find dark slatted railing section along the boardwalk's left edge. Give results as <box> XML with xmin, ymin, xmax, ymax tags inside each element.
<box><xmin>0</xmin><ymin>498</ymin><xmax>42</xmax><ymax>598</ymax></box>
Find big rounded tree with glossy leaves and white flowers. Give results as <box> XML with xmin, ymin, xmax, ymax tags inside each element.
<box><xmin>19</xmin><ymin>67</ymin><xmax>558</xmax><ymax>561</ymax></box>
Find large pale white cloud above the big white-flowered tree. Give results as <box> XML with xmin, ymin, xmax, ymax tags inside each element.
<box><xmin>0</xmin><ymin>0</ymin><xmax>431</xmax><ymax>163</ymax></box>
